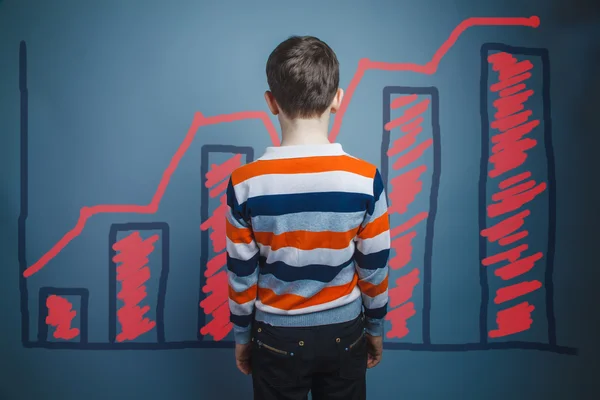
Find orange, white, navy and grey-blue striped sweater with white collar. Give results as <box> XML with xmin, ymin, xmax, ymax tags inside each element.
<box><xmin>226</xmin><ymin>143</ymin><xmax>390</xmax><ymax>344</ymax></box>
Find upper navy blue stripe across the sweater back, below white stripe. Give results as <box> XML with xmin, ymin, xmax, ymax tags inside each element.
<box><xmin>242</xmin><ymin>192</ymin><xmax>373</xmax><ymax>217</ymax></box>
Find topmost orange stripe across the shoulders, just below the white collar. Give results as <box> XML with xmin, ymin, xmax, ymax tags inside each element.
<box><xmin>231</xmin><ymin>155</ymin><xmax>375</xmax><ymax>186</ymax></box>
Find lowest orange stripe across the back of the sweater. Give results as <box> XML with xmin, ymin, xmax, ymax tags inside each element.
<box><xmin>258</xmin><ymin>274</ymin><xmax>358</xmax><ymax>310</ymax></box>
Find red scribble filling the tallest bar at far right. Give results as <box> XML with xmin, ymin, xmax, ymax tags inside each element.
<box><xmin>481</xmin><ymin>52</ymin><xmax>547</xmax><ymax>338</ymax></box>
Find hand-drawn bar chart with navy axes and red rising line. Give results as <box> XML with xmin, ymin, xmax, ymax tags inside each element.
<box><xmin>19</xmin><ymin>17</ymin><xmax>577</xmax><ymax>354</ymax></box>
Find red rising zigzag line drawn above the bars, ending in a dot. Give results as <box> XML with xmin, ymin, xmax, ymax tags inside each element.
<box><xmin>23</xmin><ymin>16</ymin><xmax>540</xmax><ymax>278</ymax></box>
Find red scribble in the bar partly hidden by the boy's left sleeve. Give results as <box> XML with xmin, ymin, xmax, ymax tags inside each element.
<box><xmin>200</xmin><ymin>154</ymin><xmax>242</xmax><ymax>341</ymax></box>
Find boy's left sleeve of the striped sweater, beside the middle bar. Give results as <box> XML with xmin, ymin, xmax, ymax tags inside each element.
<box><xmin>225</xmin><ymin>179</ymin><xmax>259</xmax><ymax>344</ymax></box>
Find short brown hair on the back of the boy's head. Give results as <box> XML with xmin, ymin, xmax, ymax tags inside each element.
<box><xmin>267</xmin><ymin>36</ymin><xmax>340</xmax><ymax>118</ymax></box>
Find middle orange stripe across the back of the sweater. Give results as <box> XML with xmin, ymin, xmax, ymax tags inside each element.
<box><xmin>254</xmin><ymin>228</ymin><xmax>358</xmax><ymax>250</ymax></box>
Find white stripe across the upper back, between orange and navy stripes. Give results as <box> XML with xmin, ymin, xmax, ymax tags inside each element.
<box><xmin>236</xmin><ymin>171</ymin><xmax>373</xmax><ymax>204</ymax></box>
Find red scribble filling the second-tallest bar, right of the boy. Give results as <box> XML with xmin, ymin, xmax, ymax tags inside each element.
<box><xmin>382</xmin><ymin>94</ymin><xmax>433</xmax><ymax>339</ymax></box>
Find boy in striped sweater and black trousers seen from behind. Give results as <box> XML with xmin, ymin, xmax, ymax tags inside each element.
<box><xmin>226</xmin><ymin>37</ymin><xmax>390</xmax><ymax>400</ymax></box>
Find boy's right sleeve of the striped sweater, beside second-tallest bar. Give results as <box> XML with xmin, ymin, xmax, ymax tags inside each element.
<box><xmin>354</xmin><ymin>170</ymin><xmax>390</xmax><ymax>336</ymax></box>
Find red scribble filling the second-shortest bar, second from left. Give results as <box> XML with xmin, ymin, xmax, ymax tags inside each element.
<box><xmin>113</xmin><ymin>231</ymin><xmax>159</xmax><ymax>342</ymax></box>
